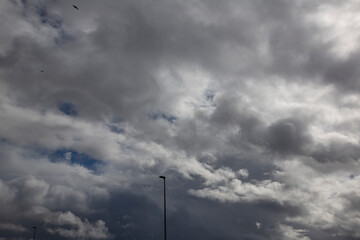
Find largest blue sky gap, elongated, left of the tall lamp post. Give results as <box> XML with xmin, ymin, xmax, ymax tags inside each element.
<box><xmin>49</xmin><ymin>149</ymin><xmax>105</xmax><ymax>173</ymax></box>
